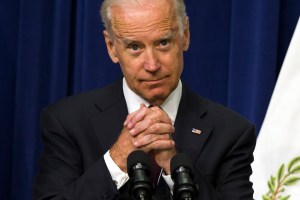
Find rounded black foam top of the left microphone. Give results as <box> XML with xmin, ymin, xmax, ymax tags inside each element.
<box><xmin>127</xmin><ymin>150</ymin><xmax>150</xmax><ymax>170</ymax></box>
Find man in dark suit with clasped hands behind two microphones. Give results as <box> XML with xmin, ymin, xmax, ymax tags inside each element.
<box><xmin>33</xmin><ymin>0</ymin><xmax>256</xmax><ymax>200</ymax></box>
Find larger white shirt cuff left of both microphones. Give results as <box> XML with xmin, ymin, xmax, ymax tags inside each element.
<box><xmin>103</xmin><ymin>150</ymin><xmax>129</xmax><ymax>189</ymax></box>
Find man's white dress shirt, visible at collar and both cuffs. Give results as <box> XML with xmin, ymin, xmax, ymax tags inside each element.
<box><xmin>104</xmin><ymin>78</ymin><xmax>182</xmax><ymax>191</ymax></box>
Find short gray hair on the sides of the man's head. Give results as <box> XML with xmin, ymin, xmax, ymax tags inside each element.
<box><xmin>100</xmin><ymin>0</ymin><xmax>187</xmax><ymax>38</ymax></box>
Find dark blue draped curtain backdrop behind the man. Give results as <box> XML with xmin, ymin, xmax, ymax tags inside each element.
<box><xmin>0</xmin><ymin>0</ymin><xmax>300</xmax><ymax>200</ymax></box>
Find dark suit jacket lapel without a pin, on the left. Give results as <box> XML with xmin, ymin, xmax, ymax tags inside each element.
<box><xmin>90</xmin><ymin>81</ymin><xmax>128</xmax><ymax>153</ymax></box>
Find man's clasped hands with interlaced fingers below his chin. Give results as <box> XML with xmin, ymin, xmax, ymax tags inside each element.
<box><xmin>110</xmin><ymin>104</ymin><xmax>176</xmax><ymax>174</ymax></box>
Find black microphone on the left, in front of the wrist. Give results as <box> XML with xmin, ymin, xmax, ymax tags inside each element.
<box><xmin>127</xmin><ymin>150</ymin><xmax>153</xmax><ymax>200</ymax></box>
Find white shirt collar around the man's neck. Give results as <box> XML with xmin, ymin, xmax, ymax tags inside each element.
<box><xmin>123</xmin><ymin>78</ymin><xmax>182</xmax><ymax>124</ymax></box>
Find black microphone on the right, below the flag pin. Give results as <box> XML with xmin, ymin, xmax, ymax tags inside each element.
<box><xmin>171</xmin><ymin>153</ymin><xmax>198</xmax><ymax>200</ymax></box>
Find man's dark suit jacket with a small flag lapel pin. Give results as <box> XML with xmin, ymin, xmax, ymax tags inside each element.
<box><xmin>33</xmin><ymin>81</ymin><xmax>256</xmax><ymax>200</ymax></box>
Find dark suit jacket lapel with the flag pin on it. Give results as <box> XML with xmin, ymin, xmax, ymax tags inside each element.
<box><xmin>173</xmin><ymin>86</ymin><xmax>213</xmax><ymax>161</ymax></box>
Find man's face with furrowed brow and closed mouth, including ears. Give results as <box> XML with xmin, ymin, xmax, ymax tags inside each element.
<box><xmin>104</xmin><ymin>0</ymin><xmax>189</xmax><ymax>105</ymax></box>
